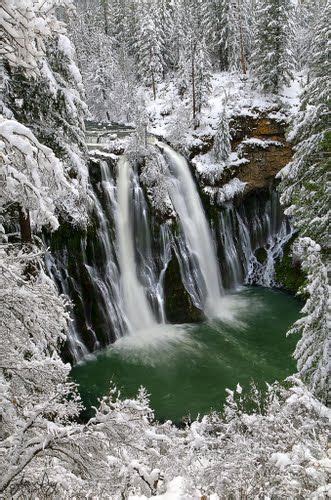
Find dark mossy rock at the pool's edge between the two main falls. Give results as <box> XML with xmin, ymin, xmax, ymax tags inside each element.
<box><xmin>164</xmin><ymin>254</ymin><xmax>204</xmax><ymax>323</ymax></box>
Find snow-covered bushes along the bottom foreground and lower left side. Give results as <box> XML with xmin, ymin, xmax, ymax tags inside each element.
<box><xmin>0</xmin><ymin>245</ymin><xmax>330</xmax><ymax>500</ymax></box>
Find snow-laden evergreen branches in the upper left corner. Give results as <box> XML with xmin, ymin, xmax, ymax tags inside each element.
<box><xmin>3</xmin><ymin>1</ymin><xmax>87</xmax><ymax>224</ymax></box>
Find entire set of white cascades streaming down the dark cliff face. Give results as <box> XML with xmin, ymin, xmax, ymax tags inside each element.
<box><xmin>47</xmin><ymin>142</ymin><xmax>292</xmax><ymax>361</ymax></box>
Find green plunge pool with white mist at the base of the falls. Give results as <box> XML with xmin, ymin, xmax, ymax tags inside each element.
<box><xmin>71</xmin><ymin>287</ymin><xmax>300</xmax><ymax>422</ymax></box>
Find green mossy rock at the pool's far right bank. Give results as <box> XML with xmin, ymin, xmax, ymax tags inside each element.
<box><xmin>275</xmin><ymin>236</ymin><xmax>306</xmax><ymax>294</ymax></box>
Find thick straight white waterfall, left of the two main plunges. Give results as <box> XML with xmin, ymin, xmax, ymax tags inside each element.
<box><xmin>116</xmin><ymin>156</ymin><xmax>156</xmax><ymax>333</ymax></box>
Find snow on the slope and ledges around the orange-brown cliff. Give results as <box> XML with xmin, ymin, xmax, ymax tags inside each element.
<box><xmin>146</xmin><ymin>72</ymin><xmax>303</xmax><ymax>202</ymax></box>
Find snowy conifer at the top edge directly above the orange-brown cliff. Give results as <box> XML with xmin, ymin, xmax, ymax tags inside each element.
<box><xmin>252</xmin><ymin>0</ymin><xmax>293</xmax><ymax>93</ymax></box>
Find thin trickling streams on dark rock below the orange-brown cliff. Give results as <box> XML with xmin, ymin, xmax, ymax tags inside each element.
<box><xmin>218</xmin><ymin>191</ymin><xmax>293</xmax><ymax>289</ymax></box>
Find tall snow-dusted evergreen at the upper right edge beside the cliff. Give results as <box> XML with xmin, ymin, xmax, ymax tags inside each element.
<box><xmin>279</xmin><ymin>2</ymin><xmax>331</xmax><ymax>247</ymax></box>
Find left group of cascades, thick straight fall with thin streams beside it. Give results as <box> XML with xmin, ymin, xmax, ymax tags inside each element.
<box><xmin>46</xmin><ymin>159</ymin><xmax>171</xmax><ymax>362</ymax></box>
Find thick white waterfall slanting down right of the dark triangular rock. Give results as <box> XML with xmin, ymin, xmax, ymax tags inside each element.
<box><xmin>157</xmin><ymin>143</ymin><xmax>223</xmax><ymax>317</ymax></box>
